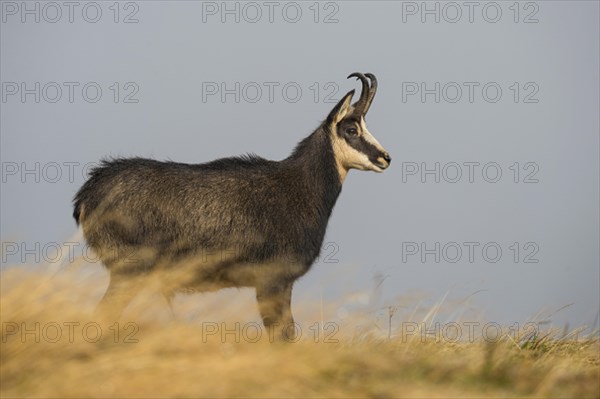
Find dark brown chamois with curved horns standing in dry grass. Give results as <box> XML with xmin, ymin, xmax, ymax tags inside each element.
<box><xmin>73</xmin><ymin>73</ymin><xmax>391</xmax><ymax>338</ymax></box>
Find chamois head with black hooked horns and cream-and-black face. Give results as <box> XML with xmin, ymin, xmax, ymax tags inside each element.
<box><xmin>325</xmin><ymin>72</ymin><xmax>392</xmax><ymax>180</ymax></box>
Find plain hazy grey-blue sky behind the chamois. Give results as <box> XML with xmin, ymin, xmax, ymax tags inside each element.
<box><xmin>0</xmin><ymin>1</ymin><xmax>600</xmax><ymax>327</ymax></box>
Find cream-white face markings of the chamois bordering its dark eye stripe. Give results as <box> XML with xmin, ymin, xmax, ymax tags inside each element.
<box><xmin>332</xmin><ymin>112</ymin><xmax>385</xmax><ymax>181</ymax></box>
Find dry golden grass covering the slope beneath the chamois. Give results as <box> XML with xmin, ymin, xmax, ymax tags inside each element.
<box><xmin>0</xmin><ymin>269</ymin><xmax>600</xmax><ymax>398</ymax></box>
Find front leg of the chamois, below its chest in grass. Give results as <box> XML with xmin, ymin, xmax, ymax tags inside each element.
<box><xmin>256</xmin><ymin>282</ymin><xmax>296</xmax><ymax>341</ymax></box>
